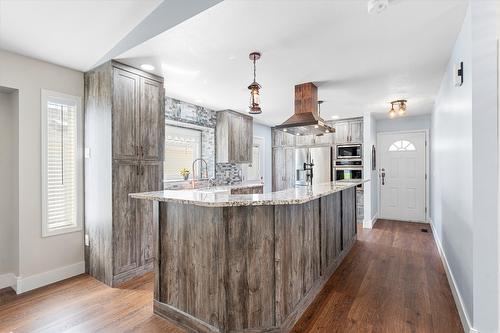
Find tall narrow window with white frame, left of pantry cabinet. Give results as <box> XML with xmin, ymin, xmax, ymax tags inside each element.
<box><xmin>42</xmin><ymin>90</ymin><xmax>82</xmax><ymax>237</ymax></box>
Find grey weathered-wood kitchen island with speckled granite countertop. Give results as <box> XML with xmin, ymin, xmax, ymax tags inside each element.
<box><xmin>131</xmin><ymin>181</ymin><xmax>362</xmax><ymax>333</ymax></box>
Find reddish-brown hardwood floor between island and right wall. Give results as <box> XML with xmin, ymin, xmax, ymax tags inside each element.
<box><xmin>293</xmin><ymin>220</ymin><xmax>463</xmax><ymax>333</ymax></box>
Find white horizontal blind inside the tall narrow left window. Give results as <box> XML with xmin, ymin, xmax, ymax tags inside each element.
<box><xmin>45</xmin><ymin>100</ymin><xmax>78</xmax><ymax>231</ymax></box>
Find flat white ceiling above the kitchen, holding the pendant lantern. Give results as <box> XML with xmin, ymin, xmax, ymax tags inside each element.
<box><xmin>119</xmin><ymin>0</ymin><xmax>467</xmax><ymax>125</ymax></box>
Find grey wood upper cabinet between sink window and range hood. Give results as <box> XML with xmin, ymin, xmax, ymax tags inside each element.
<box><xmin>215</xmin><ymin>110</ymin><xmax>253</xmax><ymax>163</ymax></box>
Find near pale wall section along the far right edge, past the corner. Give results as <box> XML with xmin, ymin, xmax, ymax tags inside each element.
<box><xmin>470</xmin><ymin>0</ymin><xmax>500</xmax><ymax>332</ymax></box>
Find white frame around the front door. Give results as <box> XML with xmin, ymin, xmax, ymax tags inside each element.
<box><xmin>376</xmin><ymin>129</ymin><xmax>430</xmax><ymax>223</ymax></box>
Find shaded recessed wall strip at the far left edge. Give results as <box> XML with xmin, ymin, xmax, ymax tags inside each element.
<box><xmin>0</xmin><ymin>90</ymin><xmax>19</xmax><ymax>274</ymax></box>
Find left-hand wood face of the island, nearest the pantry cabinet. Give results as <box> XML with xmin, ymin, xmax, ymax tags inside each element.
<box><xmin>158</xmin><ymin>202</ymin><xmax>225</xmax><ymax>332</ymax></box>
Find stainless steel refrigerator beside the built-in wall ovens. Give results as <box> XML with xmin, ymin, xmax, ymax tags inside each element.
<box><xmin>295</xmin><ymin>147</ymin><xmax>332</xmax><ymax>186</ymax></box>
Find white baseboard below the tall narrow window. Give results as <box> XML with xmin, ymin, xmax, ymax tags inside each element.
<box><xmin>15</xmin><ymin>261</ymin><xmax>85</xmax><ymax>294</ymax></box>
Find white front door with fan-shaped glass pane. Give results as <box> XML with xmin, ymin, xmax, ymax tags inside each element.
<box><xmin>377</xmin><ymin>132</ymin><xmax>426</xmax><ymax>222</ymax></box>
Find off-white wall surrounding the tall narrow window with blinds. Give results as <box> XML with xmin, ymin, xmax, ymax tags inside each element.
<box><xmin>0</xmin><ymin>51</ymin><xmax>84</xmax><ymax>285</ymax></box>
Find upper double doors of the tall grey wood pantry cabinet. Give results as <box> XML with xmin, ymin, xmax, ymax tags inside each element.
<box><xmin>113</xmin><ymin>67</ymin><xmax>165</xmax><ymax>161</ymax></box>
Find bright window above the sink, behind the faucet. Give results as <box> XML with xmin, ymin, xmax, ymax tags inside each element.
<box><xmin>163</xmin><ymin>125</ymin><xmax>201</xmax><ymax>180</ymax></box>
